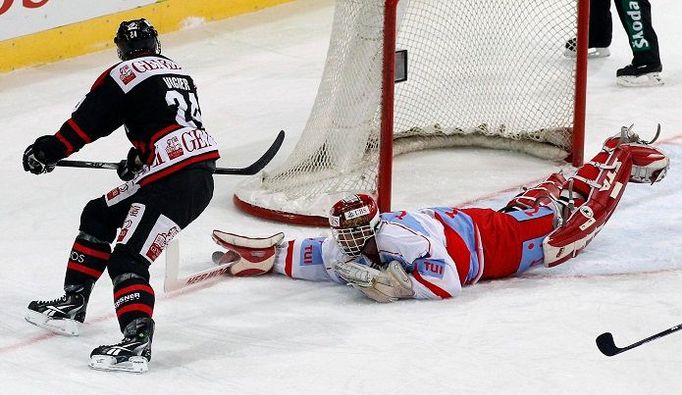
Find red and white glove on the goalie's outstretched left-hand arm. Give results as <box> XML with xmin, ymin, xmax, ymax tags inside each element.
<box><xmin>213</xmin><ymin>230</ymin><xmax>284</xmax><ymax>277</ymax></box>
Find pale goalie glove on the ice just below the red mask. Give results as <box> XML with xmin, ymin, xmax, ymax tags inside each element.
<box><xmin>334</xmin><ymin>261</ymin><xmax>414</xmax><ymax>303</ymax></box>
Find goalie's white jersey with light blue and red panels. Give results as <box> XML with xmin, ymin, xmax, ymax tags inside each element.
<box><xmin>274</xmin><ymin>208</ymin><xmax>494</xmax><ymax>299</ymax></box>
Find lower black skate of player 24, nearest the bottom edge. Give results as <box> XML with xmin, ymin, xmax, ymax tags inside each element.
<box><xmin>89</xmin><ymin>318</ymin><xmax>154</xmax><ymax>373</ymax></box>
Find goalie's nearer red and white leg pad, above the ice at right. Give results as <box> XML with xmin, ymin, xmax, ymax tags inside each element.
<box><xmin>542</xmin><ymin>147</ymin><xmax>632</xmax><ymax>267</ymax></box>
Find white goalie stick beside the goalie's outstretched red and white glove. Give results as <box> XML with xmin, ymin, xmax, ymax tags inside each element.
<box><xmin>163</xmin><ymin>239</ymin><xmax>234</xmax><ymax>293</ymax></box>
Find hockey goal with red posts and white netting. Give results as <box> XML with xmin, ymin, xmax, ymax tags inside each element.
<box><xmin>234</xmin><ymin>0</ymin><xmax>587</xmax><ymax>225</ymax></box>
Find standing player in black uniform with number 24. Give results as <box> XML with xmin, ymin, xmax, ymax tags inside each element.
<box><xmin>23</xmin><ymin>19</ymin><xmax>219</xmax><ymax>372</ymax></box>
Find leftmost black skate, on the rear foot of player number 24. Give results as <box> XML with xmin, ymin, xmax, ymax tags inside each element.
<box><xmin>24</xmin><ymin>284</ymin><xmax>93</xmax><ymax>336</ymax></box>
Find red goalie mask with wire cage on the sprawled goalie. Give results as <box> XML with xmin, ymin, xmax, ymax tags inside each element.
<box><xmin>329</xmin><ymin>194</ymin><xmax>380</xmax><ymax>257</ymax></box>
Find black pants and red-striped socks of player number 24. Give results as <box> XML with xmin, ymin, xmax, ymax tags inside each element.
<box><xmin>65</xmin><ymin>166</ymin><xmax>213</xmax><ymax>329</ymax></box>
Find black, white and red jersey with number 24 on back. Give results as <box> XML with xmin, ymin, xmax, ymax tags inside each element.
<box><xmin>49</xmin><ymin>55</ymin><xmax>220</xmax><ymax>183</ymax></box>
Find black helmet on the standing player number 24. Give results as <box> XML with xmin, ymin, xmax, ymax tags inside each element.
<box><xmin>114</xmin><ymin>18</ymin><xmax>161</xmax><ymax>60</ymax></box>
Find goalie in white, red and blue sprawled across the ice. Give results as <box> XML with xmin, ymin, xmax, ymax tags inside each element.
<box><xmin>213</xmin><ymin>127</ymin><xmax>669</xmax><ymax>302</ymax></box>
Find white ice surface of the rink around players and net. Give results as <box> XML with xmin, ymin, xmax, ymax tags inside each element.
<box><xmin>0</xmin><ymin>0</ymin><xmax>682</xmax><ymax>394</ymax></box>
